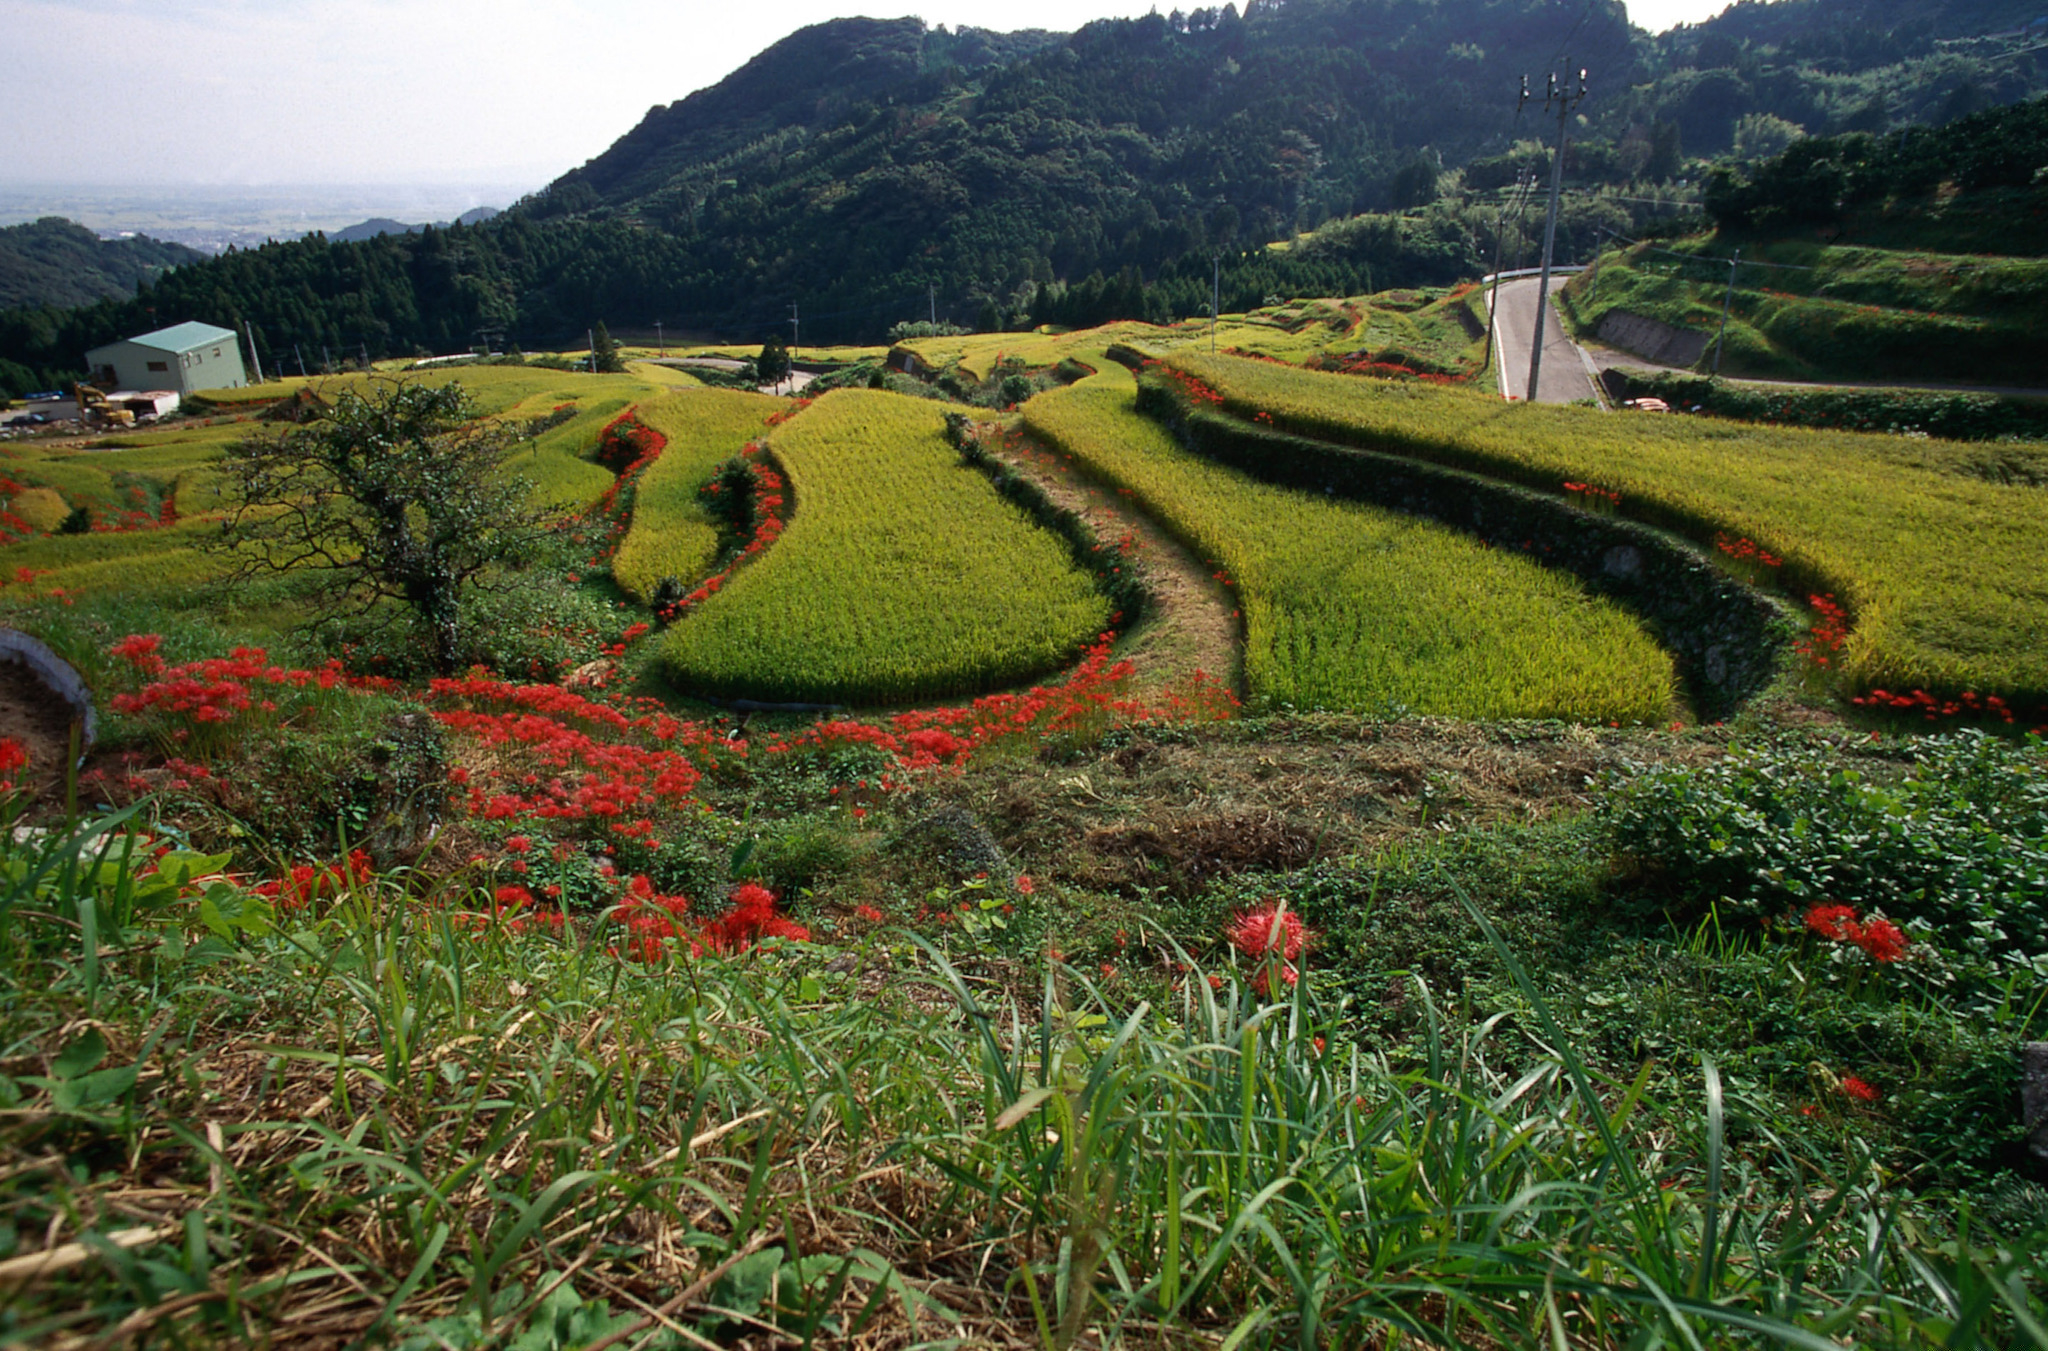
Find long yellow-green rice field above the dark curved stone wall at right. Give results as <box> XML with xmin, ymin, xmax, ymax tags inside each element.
<box><xmin>1165</xmin><ymin>350</ymin><xmax>2048</xmax><ymax>716</ymax></box>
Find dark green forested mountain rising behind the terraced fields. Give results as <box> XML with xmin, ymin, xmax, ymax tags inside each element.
<box><xmin>0</xmin><ymin>0</ymin><xmax>2048</xmax><ymax>393</ymax></box>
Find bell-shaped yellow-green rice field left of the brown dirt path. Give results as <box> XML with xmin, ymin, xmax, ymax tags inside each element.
<box><xmin>662</xmin><ymin>389</ymin><xmax>1110</xmax><ymax>704</ymax></box>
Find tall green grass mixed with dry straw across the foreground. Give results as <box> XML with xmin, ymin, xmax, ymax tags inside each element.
<box><xmin>0</xmin><ymin>817</ymin><xmax>2048</xmax><ymax>1349</ymax></box>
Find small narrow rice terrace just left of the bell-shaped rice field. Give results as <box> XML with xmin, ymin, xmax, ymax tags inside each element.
<box><xmin>598</xmin><ymin>389</ymin><xmax>788</xmax><ymax>602</ymax></box>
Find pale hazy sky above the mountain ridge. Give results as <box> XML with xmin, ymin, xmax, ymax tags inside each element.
<box><xmin>0</xmin><ymin>0</ymin><xmax>1724</xmax><ymax>188</ymax></box>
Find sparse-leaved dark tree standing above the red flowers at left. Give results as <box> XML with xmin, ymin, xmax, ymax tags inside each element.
<box><xmin>221</xmin><ymin>381</ymin><xmax>545</xmax><ymax>676</ymax></box>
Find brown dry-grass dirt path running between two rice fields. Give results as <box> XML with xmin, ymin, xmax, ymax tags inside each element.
<box><xmin>989</xmin><ymin>424</ymin><xmax>1243</xmax><ymax>694</ymax></box>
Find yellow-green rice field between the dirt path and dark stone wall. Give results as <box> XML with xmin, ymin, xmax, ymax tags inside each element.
<box><xmin>1024</xmin><ymin>366</ymin><xmax>1675</xmax><ymax>723</ymax></box>
